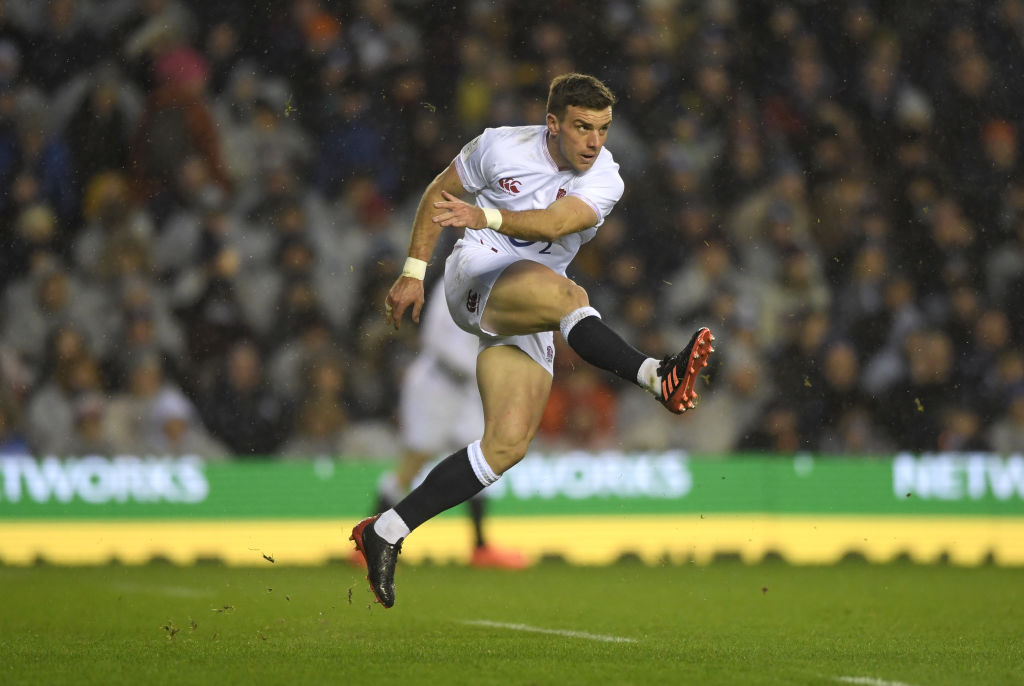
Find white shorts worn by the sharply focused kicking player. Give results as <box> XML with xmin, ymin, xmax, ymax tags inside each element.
<box><xmin>444</xmin><ymin>239</ymin><xmax>555</xmax><ymax>374</ymax></box>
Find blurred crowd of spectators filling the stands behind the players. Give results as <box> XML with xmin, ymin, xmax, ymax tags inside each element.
<box><xmin>0</xmin><ymin>0</ymin><xmax>1024</xmax><ymax>458</ymax></box>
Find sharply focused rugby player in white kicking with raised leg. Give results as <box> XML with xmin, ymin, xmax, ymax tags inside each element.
<box><xmin>351</xmin><ymin>74</ymin><xmax>713</xmax><ymax>607</ymax></box>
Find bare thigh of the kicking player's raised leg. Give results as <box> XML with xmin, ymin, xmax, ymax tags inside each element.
<box><xmin>482</xmin><ymin>260</ymin><xmax>590</xmax><ymax>336</ymax></box>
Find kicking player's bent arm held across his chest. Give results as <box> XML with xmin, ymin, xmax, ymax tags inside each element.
<box><xmin>433</xmin><ymin>191</ymin><xmax>599</xmax><ymax>241</ymax></box>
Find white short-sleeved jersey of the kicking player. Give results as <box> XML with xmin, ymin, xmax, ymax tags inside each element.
<box><xmin>455</xmin><ymin>126</ymin><xmax>625</xmax><ymax>274</ymax></box>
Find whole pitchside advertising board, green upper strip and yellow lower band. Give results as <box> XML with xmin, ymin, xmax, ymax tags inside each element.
<box><xmin>0</xmin><ymin>452</ymin><xmax>1024</xmax><ymax>564</ymax></box>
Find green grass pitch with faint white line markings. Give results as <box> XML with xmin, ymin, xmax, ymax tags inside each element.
<box><xmin>0</xmin><ymin>562</ymin><xmax>1024</xmax><ymax>686</ymax></box>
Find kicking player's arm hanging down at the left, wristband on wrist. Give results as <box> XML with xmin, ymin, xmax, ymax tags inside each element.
<box><xmin>384</xmin><ymin>163</ymin><xmax>466</xmax><ymax>329</ymax></box>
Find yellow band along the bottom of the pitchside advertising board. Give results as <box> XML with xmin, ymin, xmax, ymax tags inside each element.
<box><xmin>0</xmin><ymin>514</ymin><xmax>1024</xmax><ymax>566</ymax></box>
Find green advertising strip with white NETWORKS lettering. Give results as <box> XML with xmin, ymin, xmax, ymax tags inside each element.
<box><xmin>0</xmin><ymin>452</ymin><xmax>1024</xmax><ymax>519</ymax></box>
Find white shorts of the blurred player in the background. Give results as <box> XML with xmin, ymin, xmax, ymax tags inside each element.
<box><xmin>398</xmin><ymin>355</ymin><xmax>483</xmax><ymax>455</ymax></box>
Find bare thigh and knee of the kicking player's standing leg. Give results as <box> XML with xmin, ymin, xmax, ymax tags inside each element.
<box><xmin>476</xmin><ymin>345</ymin><xmax>551</xmax><ymax>474</ymax></box>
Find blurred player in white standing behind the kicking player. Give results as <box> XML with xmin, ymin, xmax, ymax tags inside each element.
<box><xmin>370</xmin><ymin>282</ymin><xmax>528</xmax><ymax>569</ymax></box>
